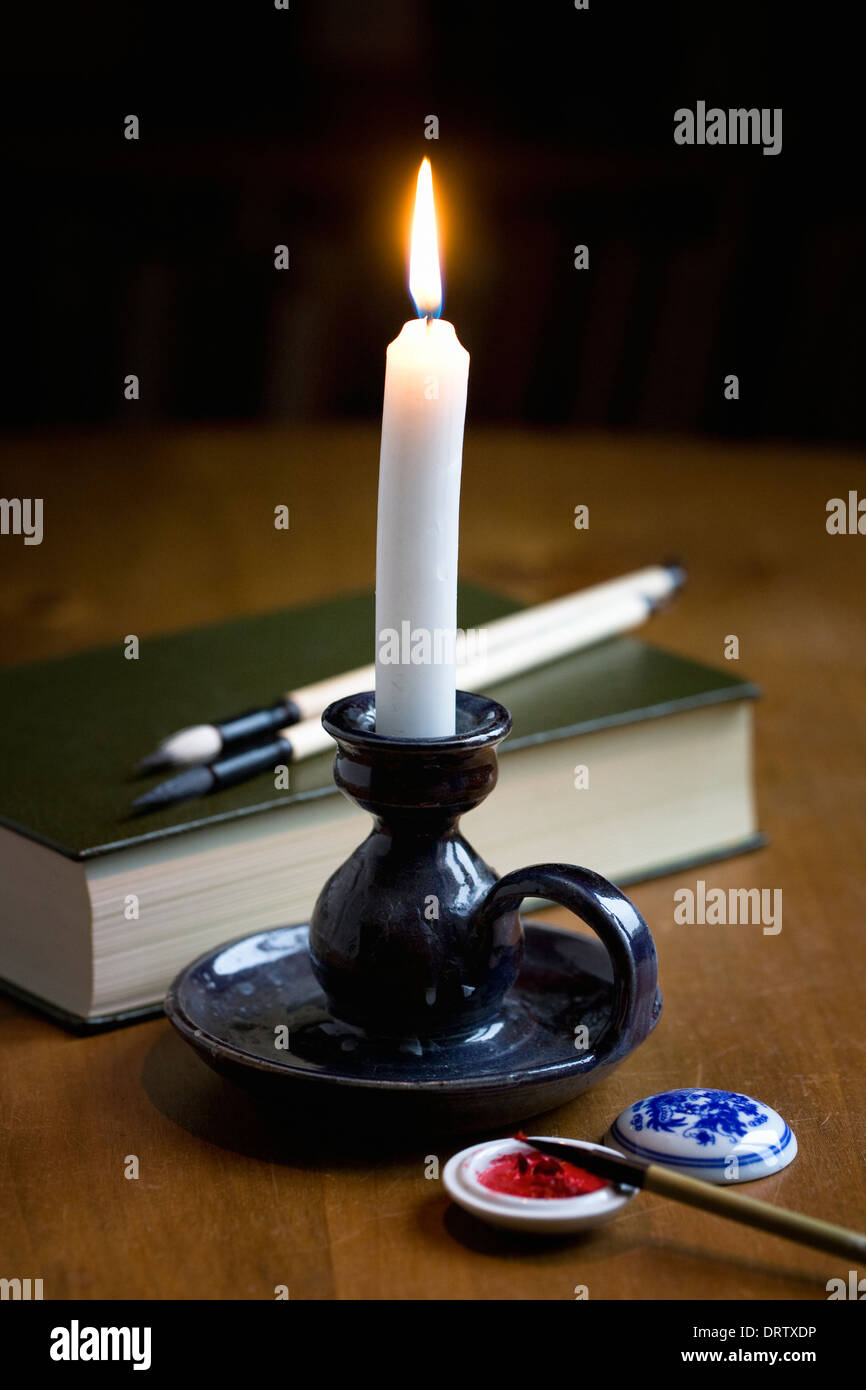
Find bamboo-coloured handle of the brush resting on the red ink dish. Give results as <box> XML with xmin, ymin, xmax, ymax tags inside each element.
<box><xmin>644</xmin><ymin>1163</ymin><xmax>866</xmax><ymax>1261</ymax></box>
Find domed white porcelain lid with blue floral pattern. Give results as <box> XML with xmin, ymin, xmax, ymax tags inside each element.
<box><xmin>605</xmin><ymin>1087</ymin><xmax>796</xmax><ymax>1183</ymax></box>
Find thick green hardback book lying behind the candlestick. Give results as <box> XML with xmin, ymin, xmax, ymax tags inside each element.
<box><xmin>0</xmin><ymin>588</ymin><xmax>760</xmax><ymax>1027</ymax></box>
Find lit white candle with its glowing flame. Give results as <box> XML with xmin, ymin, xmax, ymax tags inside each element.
<box><xmin>375</xmin><ymin>160</ymin><xmax>468</xmax><ymax>738</ymax></box>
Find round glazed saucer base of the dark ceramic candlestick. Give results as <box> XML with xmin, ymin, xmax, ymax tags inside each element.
<box><xmin>165</xmin><ymin>923</ymin><xmax>660</xmax><ymax>1133</ymax></box>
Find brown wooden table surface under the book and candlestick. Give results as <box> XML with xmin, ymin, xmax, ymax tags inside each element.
<box><xmin>0</xmin><ymin>424</ymin><xmax>866</xmax><ymax>1300</ymax></box>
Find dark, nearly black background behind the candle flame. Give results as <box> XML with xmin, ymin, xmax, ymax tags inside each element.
<box><xmin>1</xmin><ymin>0</ymin><xmax>866</xmax><ymax>441</ymax></box>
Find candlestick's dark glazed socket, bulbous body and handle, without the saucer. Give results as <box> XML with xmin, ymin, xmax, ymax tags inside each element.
<box><xmin>310</xmin><ymin>691</ymin><xmax>656</xmax><ymax>1038</ymax></box>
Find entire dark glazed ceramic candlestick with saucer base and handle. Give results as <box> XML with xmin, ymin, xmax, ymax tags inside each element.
<box><xmin>165</xmin><ymin>692</ymin><xmax>662</xmax><ymax>1137</ymax></box>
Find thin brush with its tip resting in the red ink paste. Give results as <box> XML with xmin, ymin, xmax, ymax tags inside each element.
<box><xmin>518</xmin><ymin>1134</ymin><xmax>866</xmax><ymax>1261</ymax></box>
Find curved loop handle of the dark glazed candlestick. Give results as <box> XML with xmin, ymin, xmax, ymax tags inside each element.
<box><xmin>475</xmin><ymin>865</ymin><xmax>662</xmax><ymax>1070</ymax></box>
